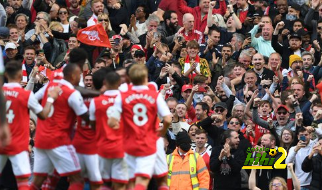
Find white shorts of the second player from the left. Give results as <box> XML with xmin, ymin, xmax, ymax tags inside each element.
<box><xmin>34</xmin><ymin>145</ymin><xmax>81</xmax><ymax>177</ymax></box>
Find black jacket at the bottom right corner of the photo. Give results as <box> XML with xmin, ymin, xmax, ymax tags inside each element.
<box><xmin>302</xmin><ymin>154</ymin><xmax>322</xmax><ymax>190</ymax></box>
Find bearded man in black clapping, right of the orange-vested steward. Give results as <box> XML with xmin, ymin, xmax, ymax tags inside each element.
<box><xmin>210</xmin><ymin>129</ymin><xmax>245</xmax><ymax>190</ymax></box>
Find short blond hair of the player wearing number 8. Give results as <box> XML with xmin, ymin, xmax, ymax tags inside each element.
<box><xmin>129</xmin><ymin>64</ymin><xmax>148</xmax><ymax>85</ymax></box>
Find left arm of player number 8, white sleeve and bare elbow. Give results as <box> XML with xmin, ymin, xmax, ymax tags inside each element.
<box><xmin>107</xmin><ymin>94</ymin><xmax>122</xmax><ymax>129</ymax></box>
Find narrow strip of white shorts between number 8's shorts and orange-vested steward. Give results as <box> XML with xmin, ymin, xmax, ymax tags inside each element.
<box><xmin>153</xmin><ymin>137</ymin><xmax>168</xmax><ymax>178</ymax></box>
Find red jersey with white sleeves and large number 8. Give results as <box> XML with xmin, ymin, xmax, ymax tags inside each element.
<box><xmin>114</xmin><ymin>86</ymin><xmax>170</xmax><ymax>156</ymax></box>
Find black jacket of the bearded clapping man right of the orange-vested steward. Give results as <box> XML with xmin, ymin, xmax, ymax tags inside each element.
<box><xmin>210</xmin><ymin>145</ymin><xmax>245</xmax><ymax>190</ymax></box>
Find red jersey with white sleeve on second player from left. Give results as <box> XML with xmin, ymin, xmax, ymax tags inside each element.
<box><xmin>35</xmin><ymin>79</ymin><xmax>88</xmax><ymax>149</ymax></box>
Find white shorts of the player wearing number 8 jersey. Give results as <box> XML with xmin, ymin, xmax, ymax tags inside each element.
<box><xmin>125</xmin><ymin>153</ymin><xmax>157</xmax><ymax>180</ymax></box>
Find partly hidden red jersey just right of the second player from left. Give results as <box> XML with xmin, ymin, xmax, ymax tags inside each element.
<box><xmin>73</xmin><ymin>98</ymin><xmax>97</xmax><ymax>154</ymax></box>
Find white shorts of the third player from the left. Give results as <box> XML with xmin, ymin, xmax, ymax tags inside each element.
<box><xmin>77</xmin><ymin>153</ymin><xmax>103</xmax><ymax>184</ymax></box>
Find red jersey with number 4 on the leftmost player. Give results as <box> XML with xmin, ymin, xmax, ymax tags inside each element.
<box><xmin>0</xmin><ymin>83</ymin><xmax>43</xmax><ymax>155</ymax></box>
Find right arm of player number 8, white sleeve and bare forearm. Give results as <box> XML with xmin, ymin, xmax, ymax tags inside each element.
<box><xmin>157</xmin><ymin>94</ymin><xmax>172</xmax><ymax>136</ymax></box>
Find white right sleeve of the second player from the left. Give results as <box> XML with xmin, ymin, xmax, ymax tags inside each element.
<box><xmin>68</xmin><ymin>90</ymin><xmax>88</xmax><ymax>116</ymax></box>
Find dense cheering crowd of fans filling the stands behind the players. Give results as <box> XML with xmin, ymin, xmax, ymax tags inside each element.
<box><xmin>0</xmin><ymin>0</ymin><xmax>322</xmax><ymax>190</ymax></box>
